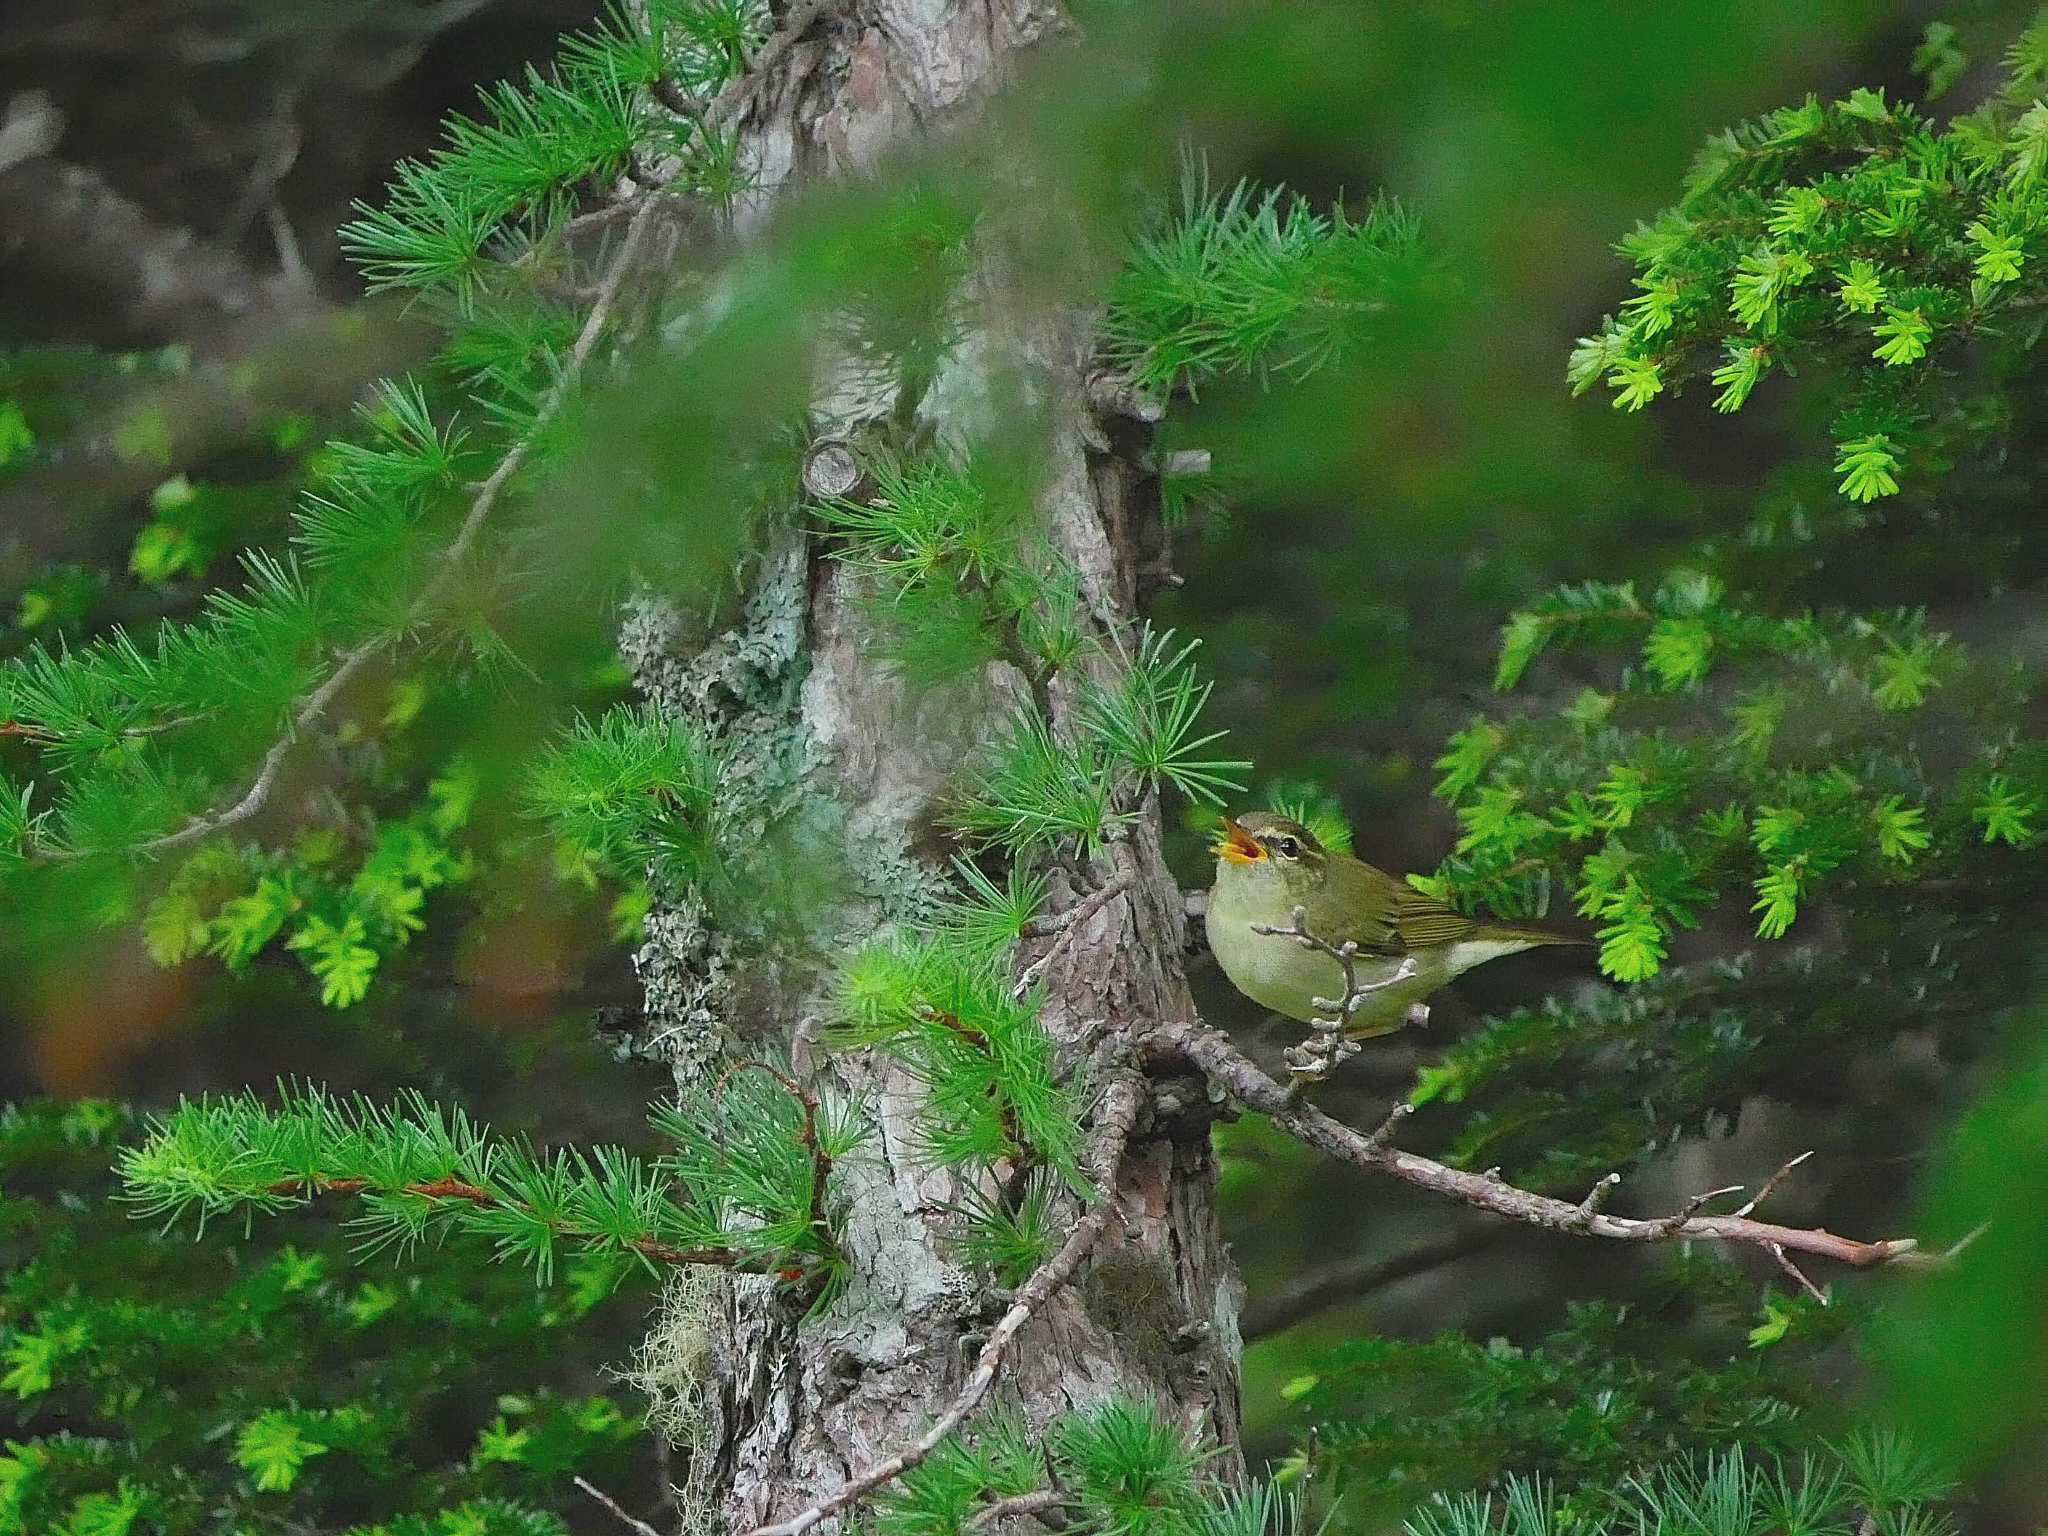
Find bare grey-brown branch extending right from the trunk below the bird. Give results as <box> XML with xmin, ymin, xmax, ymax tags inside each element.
<box><xmin>1145</xmin><ymin>1024</ymin><xmax>1946</xmax><ymax>1270</ymax></box>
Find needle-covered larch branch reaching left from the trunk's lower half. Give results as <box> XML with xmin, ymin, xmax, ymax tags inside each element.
<box><xmin>119</xmin><ymin>1071</ymin><xmax>860</xmax><ymax>1290</ymax></box>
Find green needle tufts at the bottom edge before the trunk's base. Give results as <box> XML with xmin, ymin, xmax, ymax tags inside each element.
<box><xmin>874</xmin><ymin>1399</ymin><xmax>1300</xmax><ymax>1536</ymax></box>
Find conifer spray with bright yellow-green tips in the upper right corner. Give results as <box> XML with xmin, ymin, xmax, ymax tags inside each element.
<box><xmin>1569</xmin><ymin>23</ymin><xmax>2048</xmax><ymax>502</ymax></box>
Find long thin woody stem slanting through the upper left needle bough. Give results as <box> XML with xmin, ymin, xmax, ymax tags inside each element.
<box><xmin>35</xmin><ymin>199</ymin><xmax>659</xmax><ymax>862</ymax></box>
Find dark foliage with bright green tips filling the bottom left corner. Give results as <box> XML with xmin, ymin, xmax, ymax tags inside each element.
<box><xmin>0</xmin><ymin>1100</ymin><xmax>645</xmax><ymax>1536</ymax></box>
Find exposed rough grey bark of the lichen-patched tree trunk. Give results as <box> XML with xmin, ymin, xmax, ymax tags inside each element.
<box><xmin>627</xmin><ymin>0</ymin><xmax>1239</xmax><ymax>1532</ymax></box>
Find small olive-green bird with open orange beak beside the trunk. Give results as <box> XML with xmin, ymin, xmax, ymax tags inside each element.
<box><xmin>1206</xmin><ymin>811</ymin><xmax>1587</xmax><ymax>1040</ymax></box>
